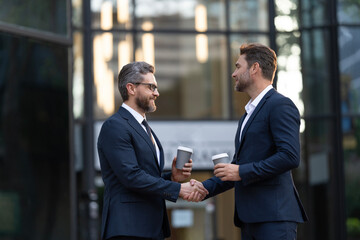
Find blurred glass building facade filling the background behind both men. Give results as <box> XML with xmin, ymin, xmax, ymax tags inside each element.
<box><xmin>0</xmin><ymin>0</ymin><xmax>360</xmax><ymax>240</ymax></box>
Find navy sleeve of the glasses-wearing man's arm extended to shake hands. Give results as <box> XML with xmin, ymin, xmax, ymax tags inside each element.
<box><xmin>98</xmin><ymin>121</ymin><xmax>180</xmax><ymax>202</ymax></box>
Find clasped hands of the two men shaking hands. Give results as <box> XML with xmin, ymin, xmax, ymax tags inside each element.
<box><xmin>179</xmin><ymin>179</ymin><xmax>209</xmax><ymax>202</ymax></box>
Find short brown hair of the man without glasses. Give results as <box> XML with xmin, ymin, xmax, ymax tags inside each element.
<box><xmin>240</xmin><ymin>43</ymin><xmax>277</xmax><ymax>81</ymax></box>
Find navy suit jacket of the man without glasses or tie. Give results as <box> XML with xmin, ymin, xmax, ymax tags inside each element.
<box><xmin>203</xmin><ymin>89</ymin><xmax>307</xmax><ymax>226</ymax></box>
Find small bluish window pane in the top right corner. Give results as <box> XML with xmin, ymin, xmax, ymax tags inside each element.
<box><xmin>337</xmin><ymin>0</ymin><xmax>360</xmax><ymax>23</ymax></box>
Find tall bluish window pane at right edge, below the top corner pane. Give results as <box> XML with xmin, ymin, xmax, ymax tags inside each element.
<box><xmin>339</xmin><ymin>27</ymin><xmax>360</xmax><ymax>114</ymax></box>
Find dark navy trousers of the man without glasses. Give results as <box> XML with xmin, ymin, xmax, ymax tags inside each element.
<box><xmin>241</xmin><ymin>222</ymin><xmax>297</xmax><ymax>240</ymax></box>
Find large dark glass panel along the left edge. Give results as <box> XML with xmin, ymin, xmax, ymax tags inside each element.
<box><xmin>0</xmin><ymin>0</ymin><xmax>76</xmax><ymax>240</ymax></box>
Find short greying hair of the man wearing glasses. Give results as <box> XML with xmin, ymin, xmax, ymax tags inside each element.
<box><xmin>118</xmin><ymin>62</ymin><xmax>155</xmax><ymax>101</ymax></box>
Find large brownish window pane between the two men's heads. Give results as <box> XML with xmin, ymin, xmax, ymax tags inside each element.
<box><xmin>136</xmin><ymin>34</ymin><xmax>229</xmax><ymax>119</ymax></box>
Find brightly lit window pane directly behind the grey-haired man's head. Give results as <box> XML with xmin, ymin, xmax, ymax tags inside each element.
<box><xmin>93</xmin><ymin>32</ymin><xmax>133</xmax><ymax>119</ymax></box>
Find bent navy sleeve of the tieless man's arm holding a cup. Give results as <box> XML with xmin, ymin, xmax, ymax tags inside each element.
<box><xmin>239</xmin><ymin>98</ymin><xmax>300</xmax><ymax>185</ymax></box>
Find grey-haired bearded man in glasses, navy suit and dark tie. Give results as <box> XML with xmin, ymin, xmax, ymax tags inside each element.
<box><xmin>98</xmin><ymin>62</ymin><xmax>208</xmax><ymax>240</ymax></box>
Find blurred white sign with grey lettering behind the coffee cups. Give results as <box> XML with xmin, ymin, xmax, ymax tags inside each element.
<box><xmin>94</xmin><ymin>121</ymin><xmax>238</xmax><ymax>170</ymax></box>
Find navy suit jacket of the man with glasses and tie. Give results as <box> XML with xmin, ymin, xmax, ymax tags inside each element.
<box><xmin>98</xmin><ymin>107</ymin><xmax>180</xmax><ymax>239</ymax></box>
